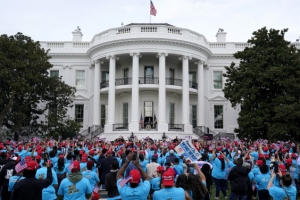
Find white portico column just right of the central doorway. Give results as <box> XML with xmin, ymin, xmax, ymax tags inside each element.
<box><xmin>157</xmin><ymin>53</ymin><xmax>168</xmax><ymax>132</ymax></box>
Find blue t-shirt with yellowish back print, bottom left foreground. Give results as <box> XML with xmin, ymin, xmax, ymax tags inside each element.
<box><xmin>57</xmin><ymin>178</ymin><xmax>93</xmax><ymax>200</ymax></box>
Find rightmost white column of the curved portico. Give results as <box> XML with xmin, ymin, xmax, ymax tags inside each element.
<box><xmin>197</xmin><ymin>60</ymin><xmax>204</xmax><ymax>126</ymax></box>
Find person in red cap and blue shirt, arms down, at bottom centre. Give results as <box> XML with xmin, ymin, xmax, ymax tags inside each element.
<box><xmin>153</xmin><ymin>168</ymin><xmax>185</xmax><ymax>200</ymax></box>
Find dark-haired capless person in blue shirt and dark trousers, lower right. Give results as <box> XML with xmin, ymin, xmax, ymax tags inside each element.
<box><xmin>254</xmin><ymin>165</ymin><xmax>270</xmax><ymax>200</ymax></box>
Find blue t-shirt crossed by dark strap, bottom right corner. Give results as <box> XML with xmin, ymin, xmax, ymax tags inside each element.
<box><xmin>269</xmin><ymin>186</ymin><xmax>297</xmax><ymax>200</ymax></box>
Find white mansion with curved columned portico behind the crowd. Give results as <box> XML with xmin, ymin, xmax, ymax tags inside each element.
<box><xmin>41</xmin><ymin>23</ymin><xmax>260</xmax><ymax>139</ymax></box>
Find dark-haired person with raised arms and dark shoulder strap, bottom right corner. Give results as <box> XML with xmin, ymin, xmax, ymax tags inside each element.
<box><xmin>268</xmin><ymin>170</ymin><xmax>297</xmax><ymax>200</ymax></box>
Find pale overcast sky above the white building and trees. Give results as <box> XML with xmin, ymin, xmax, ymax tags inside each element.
<box><xmin>0</xmin><ymin>0</ymin><xmax>300</xmax><ymax>42</ymax></box>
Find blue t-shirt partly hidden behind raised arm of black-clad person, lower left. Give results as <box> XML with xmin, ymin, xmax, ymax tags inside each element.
<box><xmin>35</xmin><ymin>167</ymin><xmax>58</xmax><ymax>200</ymax></box>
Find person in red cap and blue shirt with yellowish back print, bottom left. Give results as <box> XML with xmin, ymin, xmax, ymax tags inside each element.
<box><xmin>57</xmin><ymin>160</ymin><xmax>93</xmax><ymax>200</ymax></box>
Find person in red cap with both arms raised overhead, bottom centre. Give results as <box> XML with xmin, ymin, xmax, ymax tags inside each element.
<box><xmin>117</xmin><ymin>152</ymin><xmax>150</xmax><ymax>200</ymax></box>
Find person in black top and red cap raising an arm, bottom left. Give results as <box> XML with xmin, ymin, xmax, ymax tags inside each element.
<box><xmin>11</xmin><ymin>161</ymin><xmax>53</xmax><ymax>200</ymax></box>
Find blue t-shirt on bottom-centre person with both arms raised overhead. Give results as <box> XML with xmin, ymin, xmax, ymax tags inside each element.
<box><xmin>117</xmin><ymin>178</ymin><xmax>150</xmax><ymax>200</ymax></box>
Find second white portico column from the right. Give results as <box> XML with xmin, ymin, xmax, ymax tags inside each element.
<box><xmin>182</xmin><ymin>56</ymin><xmax>192</xmax><ymax>132</ymax></box>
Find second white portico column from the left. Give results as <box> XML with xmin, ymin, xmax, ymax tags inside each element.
<box><xmin>105</xmin><ymin>55</ymin><xmax>116</xmax><ymax>132</ymax></box>
